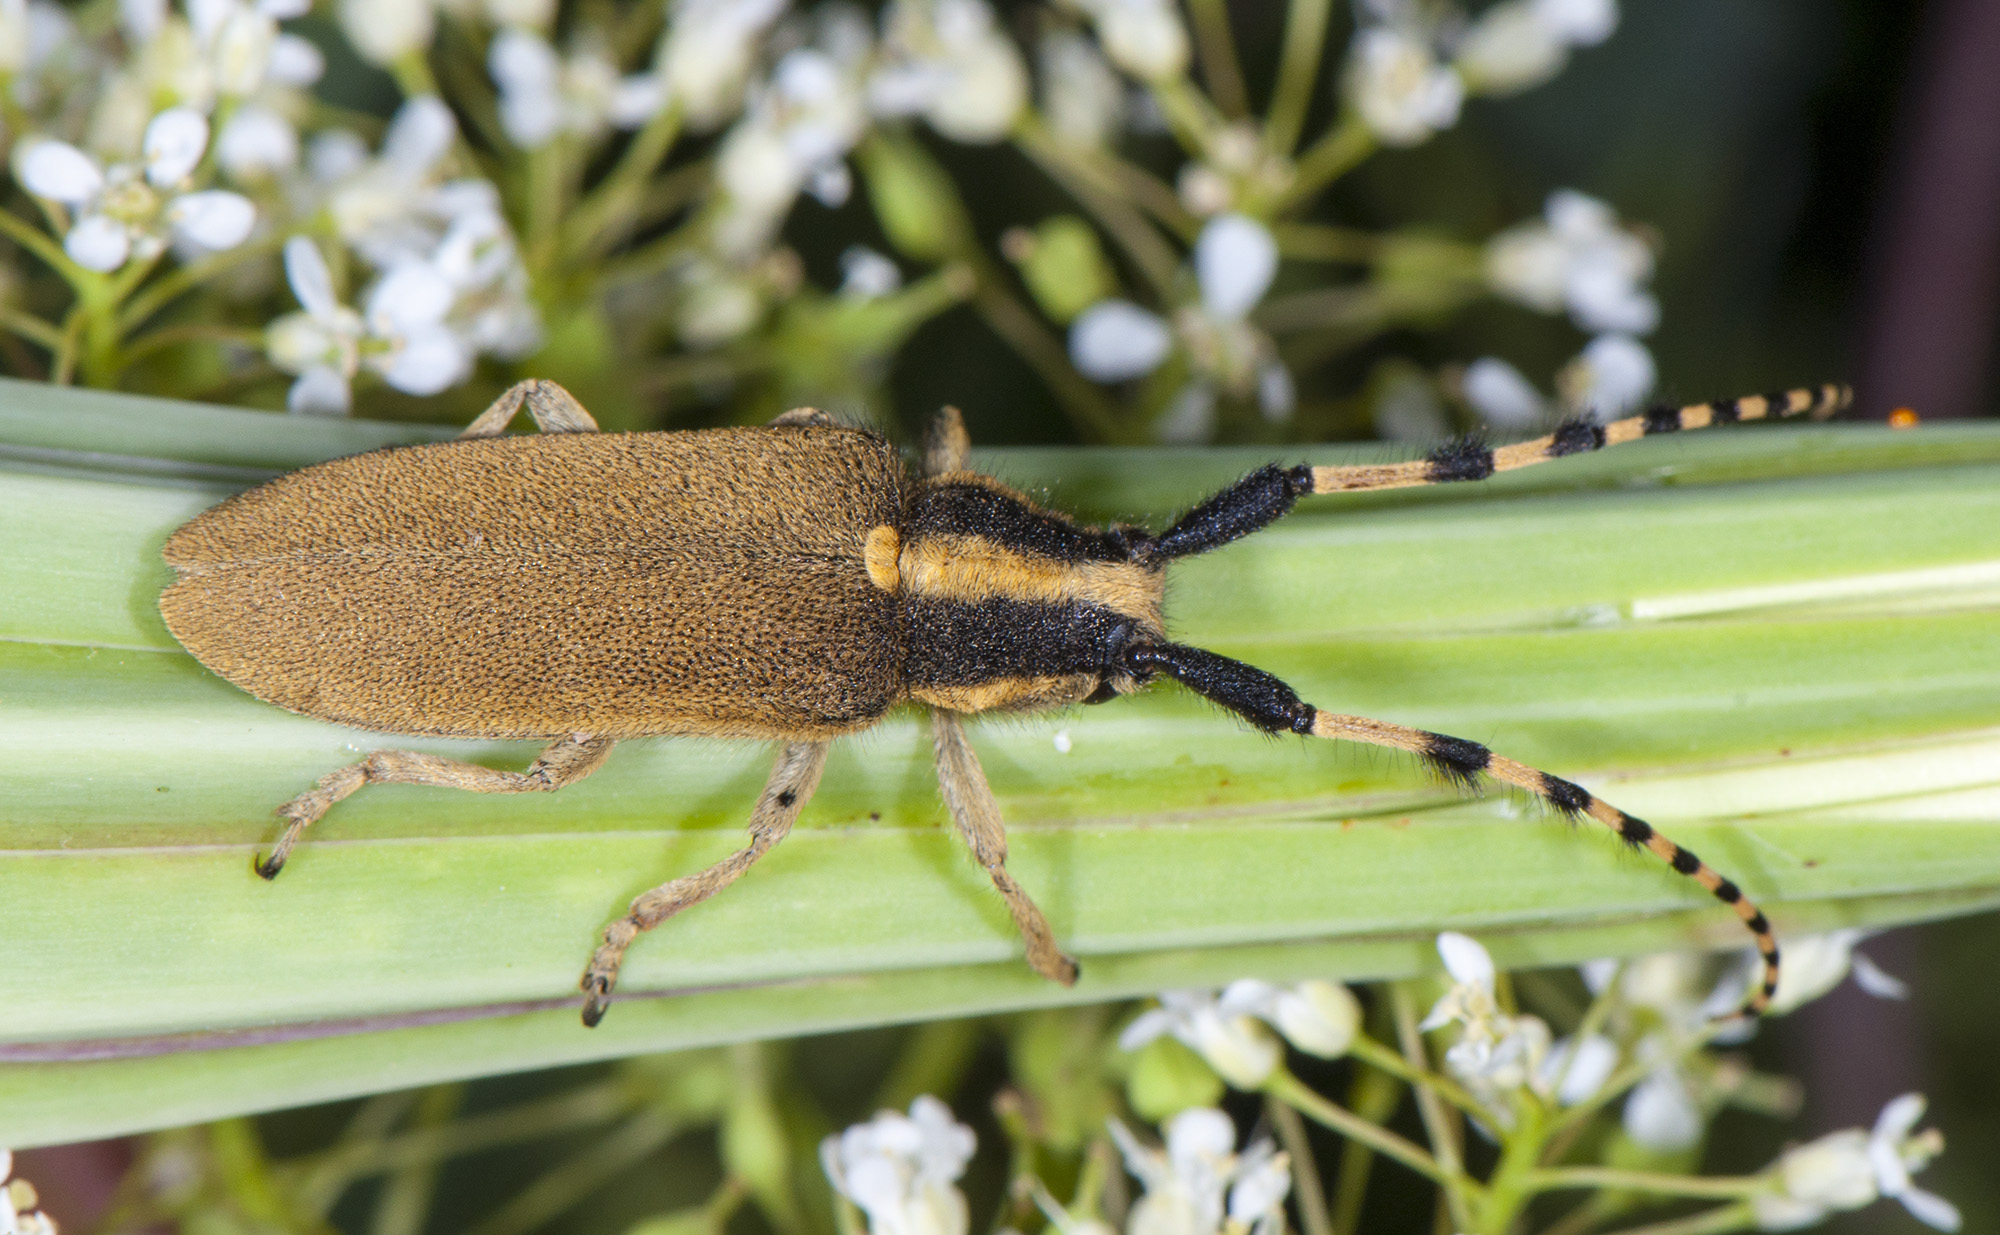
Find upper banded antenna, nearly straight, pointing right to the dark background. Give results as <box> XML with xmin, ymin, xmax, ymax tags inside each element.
<box><xmin>1138</xmin><ymin>386</ymin><xmax>1852</xmax><ymax>562</ymax></box>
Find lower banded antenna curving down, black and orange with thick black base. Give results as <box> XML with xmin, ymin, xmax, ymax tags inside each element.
<box><xmin>1126</xmin><ymin>643</ymin><xmax>1778</xmax><ymax>1017</ymax></box>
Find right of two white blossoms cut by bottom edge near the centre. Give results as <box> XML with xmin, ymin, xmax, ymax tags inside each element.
<box><xmin>1108</xmin><ymin>1107</ymin><xmax>1292</xmax><ymax>1235</ymax></box>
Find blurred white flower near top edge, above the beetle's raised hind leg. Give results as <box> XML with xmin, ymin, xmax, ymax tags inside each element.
<box><xmin>486</xmin><ymin>26</ymin><xmax>664</xmax><ymax>150</ymax></box>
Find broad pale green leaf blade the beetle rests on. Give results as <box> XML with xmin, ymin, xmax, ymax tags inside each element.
<box><xmin>0</xmin><ymin>384</ymin><xmax>2000</xmax><ymax>1145</ymax></box>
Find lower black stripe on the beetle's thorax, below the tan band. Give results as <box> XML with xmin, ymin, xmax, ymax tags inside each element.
<box><xmin>904</xmin><ymin>596</ymin><xmax>1132</xmax><ymax>687</ymax></box>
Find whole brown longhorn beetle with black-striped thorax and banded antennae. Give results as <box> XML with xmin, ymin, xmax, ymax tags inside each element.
<box><xmin>160</xmin><ymin>382</ymin><xmax>1848</xmax><ymax>1025</ymax></box>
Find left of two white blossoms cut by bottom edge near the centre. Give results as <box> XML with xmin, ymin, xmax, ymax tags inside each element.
<box><xmin>820</xmin><ymin>1093</ymin><xmax>976</xmax><ymax>1235</ymax></box>
